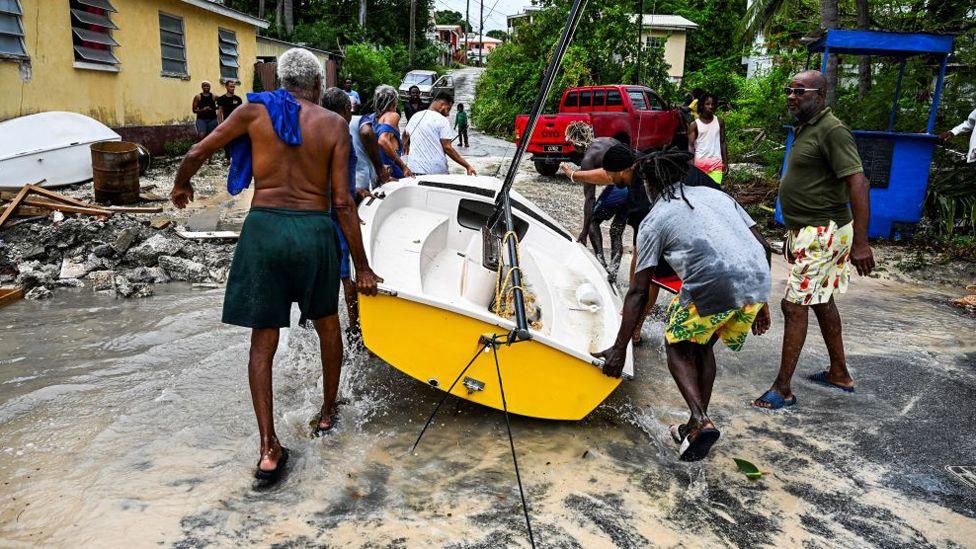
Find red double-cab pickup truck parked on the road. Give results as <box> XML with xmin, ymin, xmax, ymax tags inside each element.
<box><xmin>515</xmin><ymin>85</ymin><xmax>684</xmax><ymax>176</ymax></box>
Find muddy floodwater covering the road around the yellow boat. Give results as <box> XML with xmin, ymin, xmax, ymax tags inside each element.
<box><xmin>0</xmin><ymin>69</ymin><xmax>976</xmax><ymax>549</ymax></box>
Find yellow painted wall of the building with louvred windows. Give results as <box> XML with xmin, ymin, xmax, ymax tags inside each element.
<box><xmin>0</xmin><ymin>0</ymin><xmax>257</xmax><ymax>127</ymax></box>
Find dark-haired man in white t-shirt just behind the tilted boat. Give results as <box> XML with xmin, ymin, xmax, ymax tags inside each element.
<box><xmin>403</xmin><ymin>92</ymin><xmax>477</xmax><ymax>175</ymax></box>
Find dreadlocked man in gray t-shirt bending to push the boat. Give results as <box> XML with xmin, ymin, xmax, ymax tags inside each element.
<box><xmin>594</xmin><ymin>151</ymin><xmax>770</xmax><ymax>461</ymax></box>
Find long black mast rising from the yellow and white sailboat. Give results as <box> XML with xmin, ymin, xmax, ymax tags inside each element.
<box><xmin>487</xmin><ymin>0</ymin><xmax>586</xmax><ymax>340</ymax></box>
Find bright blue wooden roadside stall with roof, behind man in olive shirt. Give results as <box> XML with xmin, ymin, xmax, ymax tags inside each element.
<box><xmin>776</xmin><ymin>29</ymin><xmax>952</xmax><ymax>238</ymax></box>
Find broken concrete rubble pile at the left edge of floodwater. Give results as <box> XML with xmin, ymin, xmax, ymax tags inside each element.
<box><xmin>0</xmin><ymin>214</ymin><xmax>234</xmax><ymax>299</ymax></box>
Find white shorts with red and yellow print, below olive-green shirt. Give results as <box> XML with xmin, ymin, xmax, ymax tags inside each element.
<box><xmin>786</xmin><ymin>221</ymin><xmax>854</xmax><ymax>305</ymax></box>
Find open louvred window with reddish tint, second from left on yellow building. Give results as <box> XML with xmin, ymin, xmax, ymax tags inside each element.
<box><xmin>69</xmin><ymin>0</ymin><xmax>119</xmax><ymax>68</ymax></box>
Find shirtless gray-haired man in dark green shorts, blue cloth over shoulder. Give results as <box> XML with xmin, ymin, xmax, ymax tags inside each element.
<box><xmin>171</xmin><ymin>48</ymin><xmax>382</xmax><ymax>481</ymax></box>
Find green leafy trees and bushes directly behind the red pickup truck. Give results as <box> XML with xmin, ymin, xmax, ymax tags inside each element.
<box><xmin>472</xmin><ymin>0</ymin><xmax>676</xmax><ymax>136</ymax></box>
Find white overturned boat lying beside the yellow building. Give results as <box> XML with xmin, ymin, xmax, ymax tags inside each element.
<box><xmin>0</xmin><ymin>111</ymin><xmax>122</xmax><ymax>188</ymax></box>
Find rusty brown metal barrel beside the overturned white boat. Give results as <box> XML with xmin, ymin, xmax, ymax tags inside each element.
<box><xmin>91</xmin><ymin>141</ymin><xmax>139</xmax><ymax>205</ymax></box>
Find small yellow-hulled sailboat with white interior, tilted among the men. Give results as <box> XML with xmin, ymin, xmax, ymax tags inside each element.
<box><xmin>359</xmin><ymin>175</ymin><xmax>633</xmax><ymax>420</ymax></box>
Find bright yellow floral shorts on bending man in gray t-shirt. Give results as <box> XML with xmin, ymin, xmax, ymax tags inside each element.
<box><xmin>664</xmin><ymin>296</ymin><xmax>765</xmax><ymax>351</ymax></box>
